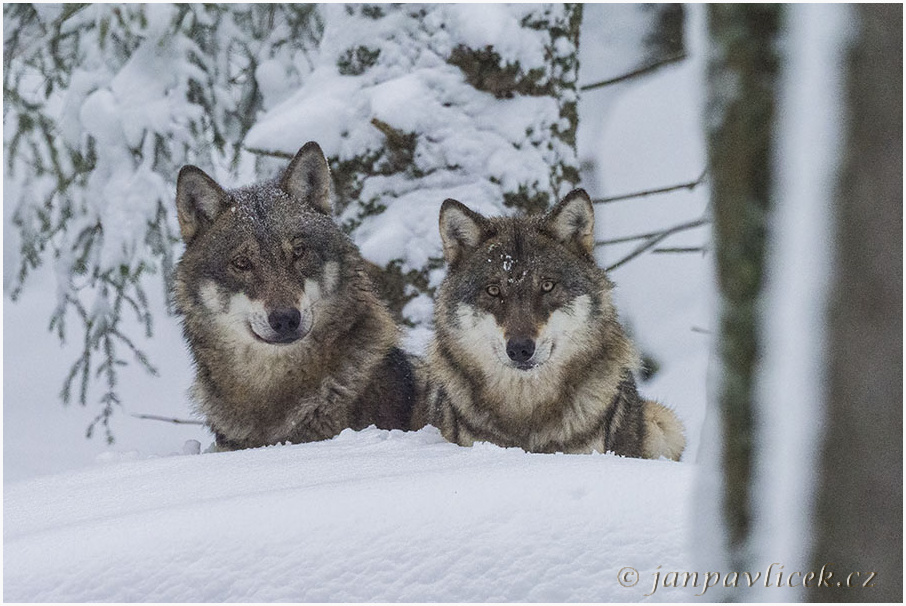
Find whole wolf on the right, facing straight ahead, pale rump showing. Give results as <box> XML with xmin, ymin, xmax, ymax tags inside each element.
<box><xmin>421</xmin><ymin>190</ymin><xmax>685</xmax><ymax>460</ymax></box>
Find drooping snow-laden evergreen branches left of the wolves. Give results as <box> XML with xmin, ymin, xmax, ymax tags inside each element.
<box><xmin>3</xmin><ymin>4</ymin><xmax>318</xmax><ymax>441</ymax></box>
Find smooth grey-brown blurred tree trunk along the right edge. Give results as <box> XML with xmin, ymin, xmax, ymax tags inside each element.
<box><xmin>808</xmin><ymin>4</ymin><xmax>903</xmax><ymax>602</ymax></box>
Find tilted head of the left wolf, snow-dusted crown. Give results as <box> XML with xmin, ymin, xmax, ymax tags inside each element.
<box><xmin>176</xmin><ymin>142</ymin><xmax>356</xmax><ymax>348</ymax></box>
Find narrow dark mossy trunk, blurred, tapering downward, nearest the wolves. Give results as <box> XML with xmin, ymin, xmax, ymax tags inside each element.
<box><xmin>706</xmin><ymin>4</ymin><xmax>783</xmax><ymax>570</ymax></box>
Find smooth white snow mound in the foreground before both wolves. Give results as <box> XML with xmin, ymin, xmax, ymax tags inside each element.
<box><xmin>3</xmin><ymin>428</ymin><xmax>693</xmax><ymax>602</ymax></box>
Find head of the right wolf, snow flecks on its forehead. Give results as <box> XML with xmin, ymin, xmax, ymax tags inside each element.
<box><xmin>436</xmin><ymin>189</ymin><xmax>615</xmax><ymax>376</ymax></box>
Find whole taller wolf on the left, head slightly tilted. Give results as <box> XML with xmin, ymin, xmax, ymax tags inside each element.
<box><xmin>175</xmin><ymin>142</ymin><xmax>414</xmax><ymax>450</ymax></box>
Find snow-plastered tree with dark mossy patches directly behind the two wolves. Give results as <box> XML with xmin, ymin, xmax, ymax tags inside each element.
<box><xmin>245</xmin><ymin>4</ymin><xmax>582</xmax><ymax>325</ymax></box>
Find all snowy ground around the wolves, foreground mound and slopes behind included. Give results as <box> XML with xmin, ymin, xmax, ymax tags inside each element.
<box><xmin>3</xmin><ymin>8</ymin><xmax>713</xmax><ymax>601</ymax></box>
